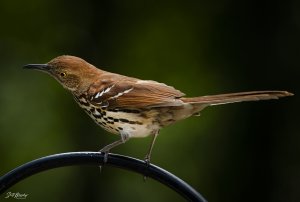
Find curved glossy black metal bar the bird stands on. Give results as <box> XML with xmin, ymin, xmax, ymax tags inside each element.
<box><xmin>0</xmin><ymin>152</ymin><xmax>206</xmax><ymax>201</ymax></box>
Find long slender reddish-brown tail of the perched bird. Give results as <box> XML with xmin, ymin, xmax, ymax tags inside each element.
<box><xmin>181</xmin><ymin>91</ymin><xmax>293</xmax><ymax>113</ymax></box>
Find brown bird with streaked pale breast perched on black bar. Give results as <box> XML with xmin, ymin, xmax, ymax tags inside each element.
<box><xmin>24</xmin><ymin>55</ymin><xmax>293</xmax><ymax>164</ymax></box>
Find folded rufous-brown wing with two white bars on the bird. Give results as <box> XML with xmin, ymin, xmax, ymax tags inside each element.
<box><xmin>89</xmin><ymin>77</ymin><xmax>184</xmax><ymax>109</ymax></box>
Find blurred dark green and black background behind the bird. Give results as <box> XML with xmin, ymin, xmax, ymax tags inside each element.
<box><xmin>0</xmin><ymin>0</ymin><xmax>300</xmax><ymax>202</ymax></box>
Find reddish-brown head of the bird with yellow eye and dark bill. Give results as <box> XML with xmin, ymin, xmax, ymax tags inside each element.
<box><xmin>24</xmin><ymin>55</ymin><xmax>101</xmax><ymax>93</ymax></box>
